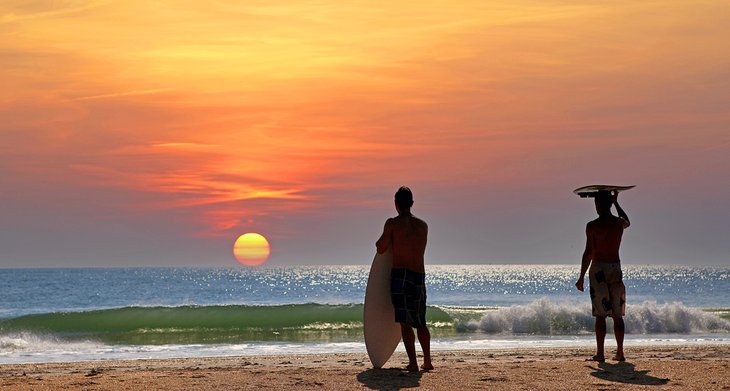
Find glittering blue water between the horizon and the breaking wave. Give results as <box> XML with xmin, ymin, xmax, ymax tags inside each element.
<box><xmin>0</xmin><ymin>265</ymin><xmax>730</xmax><ymax>317</ymax></box>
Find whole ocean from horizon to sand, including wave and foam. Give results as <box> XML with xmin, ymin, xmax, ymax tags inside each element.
<box><xmin>0</xmin><ymin>265</ymin><xmax>730</xmax><ymax>364</ymax></box>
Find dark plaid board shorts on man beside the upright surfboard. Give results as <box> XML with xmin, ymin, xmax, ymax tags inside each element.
<box><xmin>390</xmin><ymin>268</ymin><xmax>426</xmax><ymax>328</ymax></box>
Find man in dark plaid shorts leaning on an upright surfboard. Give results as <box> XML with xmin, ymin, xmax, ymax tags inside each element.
<box><xmin>375</xmin><ymin>186</ymin><xmax>433</xmax><ymax>372</ymax></box>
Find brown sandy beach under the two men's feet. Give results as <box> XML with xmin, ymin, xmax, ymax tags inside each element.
<box><xmin>0</xmin><ymin>345</ymin><xmax>730</xmax><ymax>390</ymax></box>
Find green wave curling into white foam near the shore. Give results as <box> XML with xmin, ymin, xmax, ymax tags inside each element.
<box><xmin>0</xmin><ymin>298</ymin><xmax>730</xmax><ymax>353</ymax></box>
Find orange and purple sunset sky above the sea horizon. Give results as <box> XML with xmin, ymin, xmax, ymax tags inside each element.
<box><xmin>0</xmin><ymin>0</ymin><xmax>730</xmax><ymax>267</ymax></box>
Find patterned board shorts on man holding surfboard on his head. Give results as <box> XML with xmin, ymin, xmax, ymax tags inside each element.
<box><xmin>588</xmin><ymin>262</ymin><xmax>626</xmax><ymax>316</ymax></box>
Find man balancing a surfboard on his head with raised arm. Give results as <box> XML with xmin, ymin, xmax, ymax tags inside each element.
<box><xmin>575</xmin><ymin>191</ymin><xmax>631</xmax><ymax>362</ymax></box>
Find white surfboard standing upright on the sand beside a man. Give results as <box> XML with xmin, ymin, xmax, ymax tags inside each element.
<box><xmin>363</xmin><ymin>248</ymin><xmax>401</xmax><ymax>368</ymax></box>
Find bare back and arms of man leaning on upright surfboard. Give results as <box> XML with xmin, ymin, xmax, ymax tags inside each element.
<box><xmin>376</xmin><ymin>213</ymin><xmax>428</xmax><ymax>273</ymax></box>
